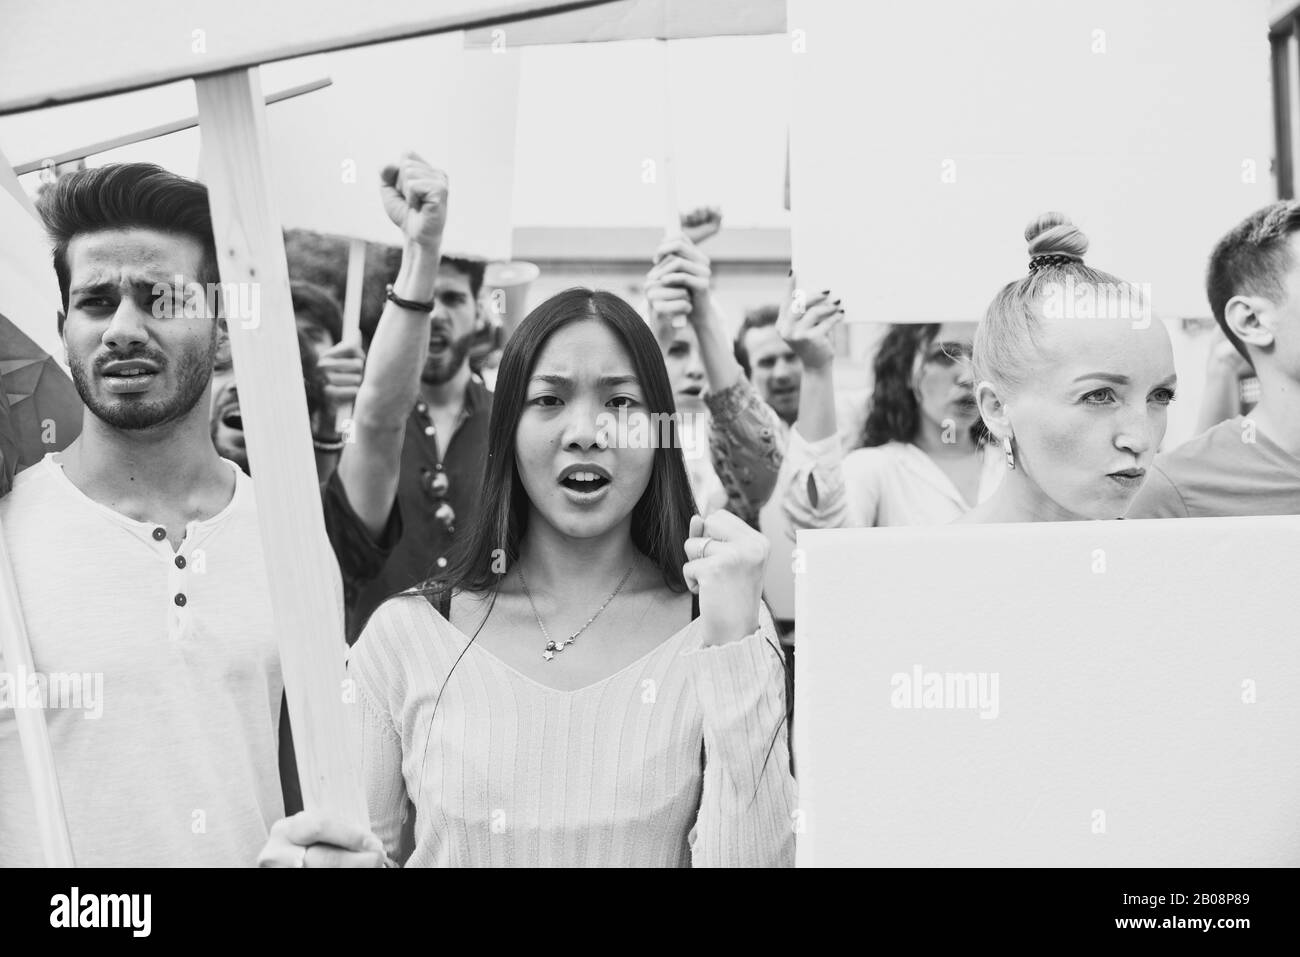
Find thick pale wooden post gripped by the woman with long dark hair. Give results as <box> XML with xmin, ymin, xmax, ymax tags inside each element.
<box><xmin>195</xmin><ymin>68</ymin><xmax>369</xmax><ymax>830</ymax></box>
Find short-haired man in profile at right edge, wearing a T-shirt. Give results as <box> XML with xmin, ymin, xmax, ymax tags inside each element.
<box><xmin>1127</xmin><ymin>200</ymin><xmax>1300</xmax><ymax>519</ymax></box>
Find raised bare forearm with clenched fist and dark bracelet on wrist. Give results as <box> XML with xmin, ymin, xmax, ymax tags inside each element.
<box><xmin>338</xmin><ymin>153</ymin><xmax>447</xmax><ymax>537</ymax></box>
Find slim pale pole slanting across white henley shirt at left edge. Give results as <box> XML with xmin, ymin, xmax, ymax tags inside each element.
<box><xmin>0</xmin><ymin>528</ymin><xmax>74</xmax><ymax>867</ymax></box>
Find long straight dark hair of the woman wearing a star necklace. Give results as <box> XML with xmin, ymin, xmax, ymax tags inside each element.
<box><xmin>420</xmin><ymin>289</ymin><xmax>696</xmax><ymax>608</ymax></box>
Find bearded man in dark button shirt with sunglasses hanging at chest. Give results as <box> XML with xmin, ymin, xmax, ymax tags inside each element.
<box><xmin>339</xmin><ymin>256</ymin><xmax>491</xmax><ymax>642</ymax></box>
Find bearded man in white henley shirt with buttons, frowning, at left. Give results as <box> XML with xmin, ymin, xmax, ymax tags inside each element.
<box><xmin>0</xmin><ymin>155</ymin><xmax>446</xmax><ymax>867</ymax></box>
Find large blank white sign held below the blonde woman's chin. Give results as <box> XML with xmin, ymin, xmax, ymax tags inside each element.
<box><xmin>794</xmin><ymin>516</ymin><xmax>1300</xmax><ymax>867</ymax></box>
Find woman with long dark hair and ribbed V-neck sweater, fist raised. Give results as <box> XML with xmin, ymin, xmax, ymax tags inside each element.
<box><xmin>263</xmin><ymin>290</ymin><xmax>794</xmax><ymax>867</ymax></box>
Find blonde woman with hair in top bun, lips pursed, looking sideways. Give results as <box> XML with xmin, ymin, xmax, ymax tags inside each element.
<box><xmin>959</xmin><ymin>213</ymin><xmax>1178</xmax><ymax>523</ymax></box>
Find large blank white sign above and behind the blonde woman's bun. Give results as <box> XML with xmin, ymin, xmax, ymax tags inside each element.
<box><xmin>788</xmin><ymin>0</ymin><xmax>1277</xmax><ymax>322</ymax></box>
